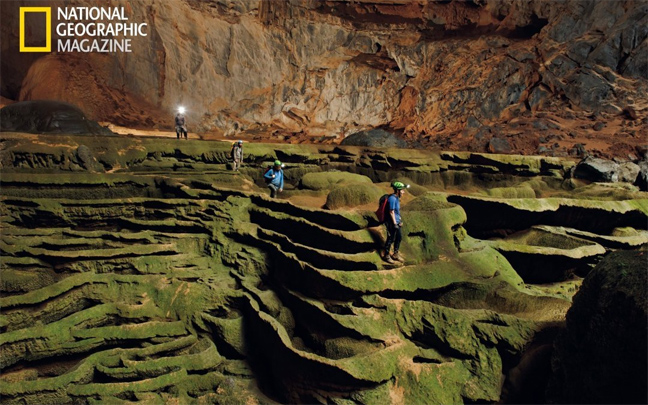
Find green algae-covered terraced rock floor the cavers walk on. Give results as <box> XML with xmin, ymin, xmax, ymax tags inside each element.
<box><xmin>0</xmin><ymin>133</ymin><xmax>648</xmax><ymax>404</ymax></box>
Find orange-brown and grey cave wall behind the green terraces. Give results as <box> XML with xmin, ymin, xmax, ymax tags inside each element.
<box><xmin>2</xmin><ymin>0</ymin><xmax>648</xmax><ymax>159</ymax></box>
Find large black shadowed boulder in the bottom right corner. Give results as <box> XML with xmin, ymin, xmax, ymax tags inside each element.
<box><xmin>547</xmin><ymin>251</ymin><xmax>648</xmax><ymax>404</ymax></box>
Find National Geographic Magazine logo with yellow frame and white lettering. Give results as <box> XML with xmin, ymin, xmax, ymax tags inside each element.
<box><xmin>20</xmin><ymin>7</ymin><xmax>148</xmax><ymax>52</ymax></box>
